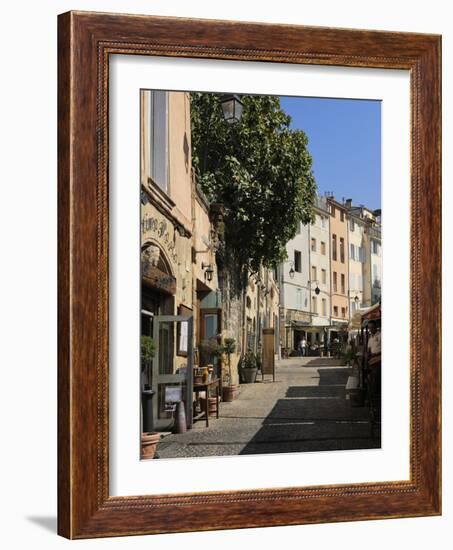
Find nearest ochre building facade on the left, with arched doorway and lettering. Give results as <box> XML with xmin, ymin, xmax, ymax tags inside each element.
<box><xmin>140</xmin><ymin>90</ymin><xmax>218</xmax><ymax>429</ymax></box>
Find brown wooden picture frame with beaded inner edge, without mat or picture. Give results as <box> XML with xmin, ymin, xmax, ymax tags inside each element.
<box><xmin>58</xmin><ymin>12</ymin><xmax>441</xmax><ymax>538</ymax></box>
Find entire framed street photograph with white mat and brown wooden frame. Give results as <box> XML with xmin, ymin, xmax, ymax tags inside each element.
<box><xmin>58</xmin><ymin>12</ymin><xmax>441</xmax><ymax>538</ymax></box>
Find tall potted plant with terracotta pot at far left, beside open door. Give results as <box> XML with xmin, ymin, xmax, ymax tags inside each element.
<box><xmin>140</xmin><ymin>335</ymin><xmax>160</xmax><ymax>458</ymax></box>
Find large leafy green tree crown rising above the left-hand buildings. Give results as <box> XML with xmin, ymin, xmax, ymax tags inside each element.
<box><xmin>191</xmin><ymin>93</ymin><xmax>316</xmax><ymax>273</ymax></box>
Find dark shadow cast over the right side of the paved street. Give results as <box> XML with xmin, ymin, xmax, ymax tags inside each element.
<box><xmin>240</xmin><ymin>367</ymin><xmax>380</xmax><ymax>454</ymax></box>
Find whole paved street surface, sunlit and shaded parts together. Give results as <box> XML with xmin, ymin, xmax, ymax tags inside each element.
<box><xmin>158</xmin><ymin>357</ymin><xmax>380</xmax><ymax>458</ymax></box>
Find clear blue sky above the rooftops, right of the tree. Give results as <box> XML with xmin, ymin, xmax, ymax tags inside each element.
<box><xmin>280</xmin><ymin>97</ymin><xmax>381</xmax><ymax>209</ymax></box>
